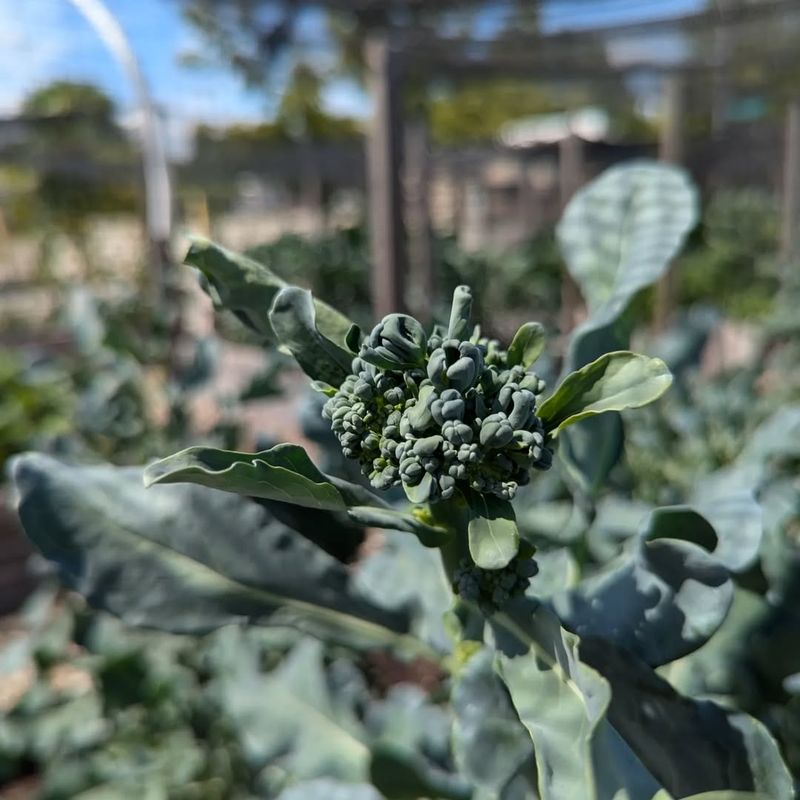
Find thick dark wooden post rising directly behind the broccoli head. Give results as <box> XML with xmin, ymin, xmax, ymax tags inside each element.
<box><xmin>364</xmin><ymin>30</ymin><xmax>406</xmax><ymax>319</ymax></box>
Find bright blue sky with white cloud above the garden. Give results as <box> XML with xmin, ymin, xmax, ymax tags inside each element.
<box><xmin>0</xmin><ymin>0</ymin><xmax>702</xmax><ymax>153</ymax></box>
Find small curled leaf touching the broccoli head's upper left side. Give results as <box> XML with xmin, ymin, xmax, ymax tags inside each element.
<box><xmin>269</xmin><ymin>286</ymin><xmax>353</xmax><ymax>386</ymax></box>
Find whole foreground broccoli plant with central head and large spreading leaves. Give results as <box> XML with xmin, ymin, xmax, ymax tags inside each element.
<box><xmin>14</xmin><ymin>164</ymin><xmax>793</xmax><ymax>800</ymax></box>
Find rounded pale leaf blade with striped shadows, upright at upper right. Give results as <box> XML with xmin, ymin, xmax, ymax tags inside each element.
<box><xmin>557</xmin><ymin>161</ymin><xmax>698</xmax><ymax>321</ymax></box>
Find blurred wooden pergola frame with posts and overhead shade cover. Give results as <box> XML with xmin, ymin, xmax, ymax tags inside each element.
<box><xmin>350</xmin><ymin>0</ymin><xmax>800</xmax><ymax>317</ymax></box>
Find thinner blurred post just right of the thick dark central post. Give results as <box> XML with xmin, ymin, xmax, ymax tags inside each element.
<box><xmin>405</xmin><ymin>114</ymin><xmax>436</xmax><ymax>324</ymax></box>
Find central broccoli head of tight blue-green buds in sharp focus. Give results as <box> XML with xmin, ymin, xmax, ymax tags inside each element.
<box><xmin>323</xmin><ymin>287</ymin><xmax>552</xmax><ymax>500</ymax></box>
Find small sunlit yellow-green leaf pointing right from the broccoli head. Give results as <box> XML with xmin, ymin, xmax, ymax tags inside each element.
<box><xmin>538</xmin><ymin>350</ymin><xmax>672</xmax><ymax>435</ymax></box>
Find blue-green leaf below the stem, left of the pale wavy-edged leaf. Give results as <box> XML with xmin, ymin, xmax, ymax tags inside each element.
<box><xmin>451</xmin><ymin>648</ymin><xmax>533</xmax><ymax>794</ymax></box>
